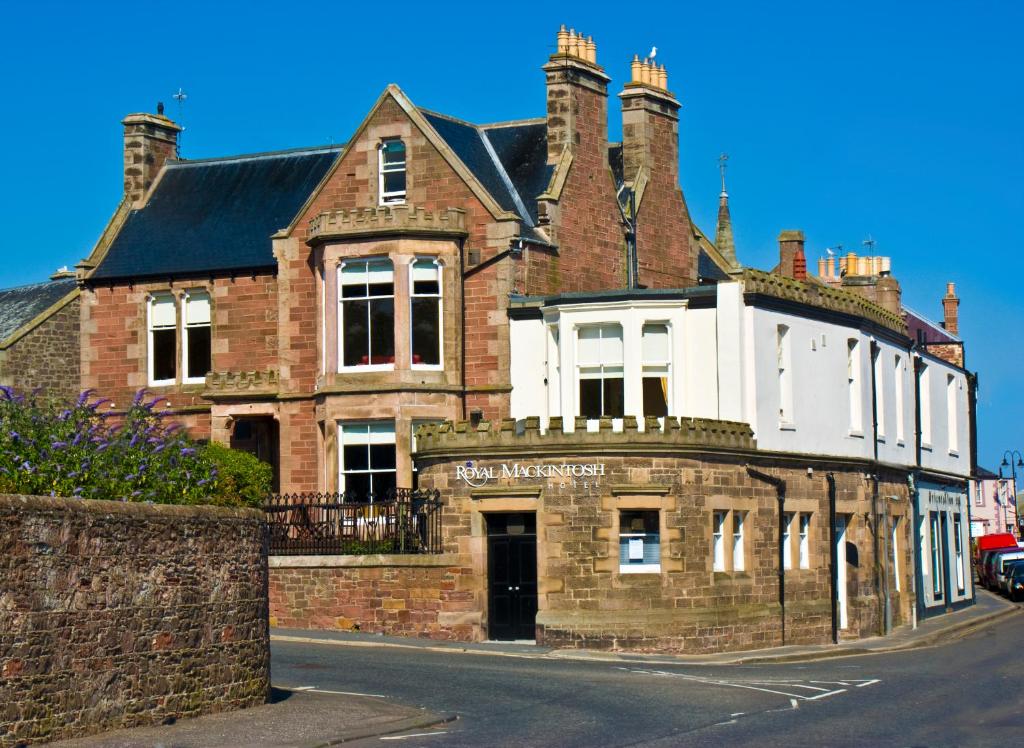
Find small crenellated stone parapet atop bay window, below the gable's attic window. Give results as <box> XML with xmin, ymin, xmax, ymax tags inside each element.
<box><xmin>307</xmin><ymin>205</ymin><xmax>468</xmax><ymax>244</ymax></box>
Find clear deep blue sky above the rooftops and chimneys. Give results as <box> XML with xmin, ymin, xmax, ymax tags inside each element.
<box><xmin>0</xmin><ymin>0</ymin><xmax>1024</xmax><ymax>468</ymax></box>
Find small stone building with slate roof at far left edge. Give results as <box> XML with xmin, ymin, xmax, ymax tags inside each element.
<box><xmin>0</xmin><ymin>272</ymin><xmax>79</xmax><ymax>399</ymax></box>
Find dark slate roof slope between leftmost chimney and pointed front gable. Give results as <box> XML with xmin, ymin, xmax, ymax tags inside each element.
<box><xmin>90</xmin><ymin>146</ymin><xmax>341</xmax><ymax>280</ymax></box>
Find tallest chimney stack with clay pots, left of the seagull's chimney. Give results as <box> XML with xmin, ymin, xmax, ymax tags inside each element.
<box><xmin>544</xmin><ymin>26</ymin><xmax>610</xmax><ymax>164</ymax></box>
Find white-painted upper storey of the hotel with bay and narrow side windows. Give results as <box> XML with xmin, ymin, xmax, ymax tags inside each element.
<box><xmin>511</xmin><ymin>282</ymin><xmax>970</xmax><ymax>476</ymax></box>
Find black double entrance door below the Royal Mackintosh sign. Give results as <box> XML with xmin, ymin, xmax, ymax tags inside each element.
<box><xmin>486</xmin><ymin>512</ymin><xmax>537</xmax><ymax>640</ymax></box>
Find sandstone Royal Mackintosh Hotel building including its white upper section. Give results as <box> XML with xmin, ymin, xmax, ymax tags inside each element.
<box><xmin>74</xmin><ymin>29</ymin><xmax>973</xmax><ymax>651</ymax></box>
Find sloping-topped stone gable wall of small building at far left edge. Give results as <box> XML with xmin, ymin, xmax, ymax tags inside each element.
<box><xmin>0</xmin><ymin>297</ymin><xmax>80</xmax><ymax>399</ymax></box>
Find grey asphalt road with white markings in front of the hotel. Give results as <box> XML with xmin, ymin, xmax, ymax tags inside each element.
<box><xmin>272</xmin><ymin>616</ymin><xmax>1024</xmax><ymax>748</ymax></box>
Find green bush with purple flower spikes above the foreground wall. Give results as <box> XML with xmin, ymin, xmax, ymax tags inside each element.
<box><xmin>0</xmin><ymin>386</ymin><xmax>232</xmax><ymax>504</ymax></box>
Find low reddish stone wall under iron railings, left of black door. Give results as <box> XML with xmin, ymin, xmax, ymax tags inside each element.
<box><xmin>270</xmin><ymin>554</ymin><xmax>475</xmax><ymax>640</ymax></box>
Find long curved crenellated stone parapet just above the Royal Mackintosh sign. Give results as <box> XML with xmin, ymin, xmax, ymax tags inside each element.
<box><xmin>416</xmin><ymin>416</ymin><xmax>757</xmax><ymax>458</ymax></box>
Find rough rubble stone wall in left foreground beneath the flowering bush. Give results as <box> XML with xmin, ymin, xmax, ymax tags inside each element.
<box><xmin>0</xmin><ymin>495</ymin><xmax>270</xmax><ymax>745</ymax></box>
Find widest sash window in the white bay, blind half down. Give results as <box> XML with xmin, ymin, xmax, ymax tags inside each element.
<box><xmin>577</xmin><ymin>325</ymin><xmax>625</xmax><ymax>418</ymax></box>
